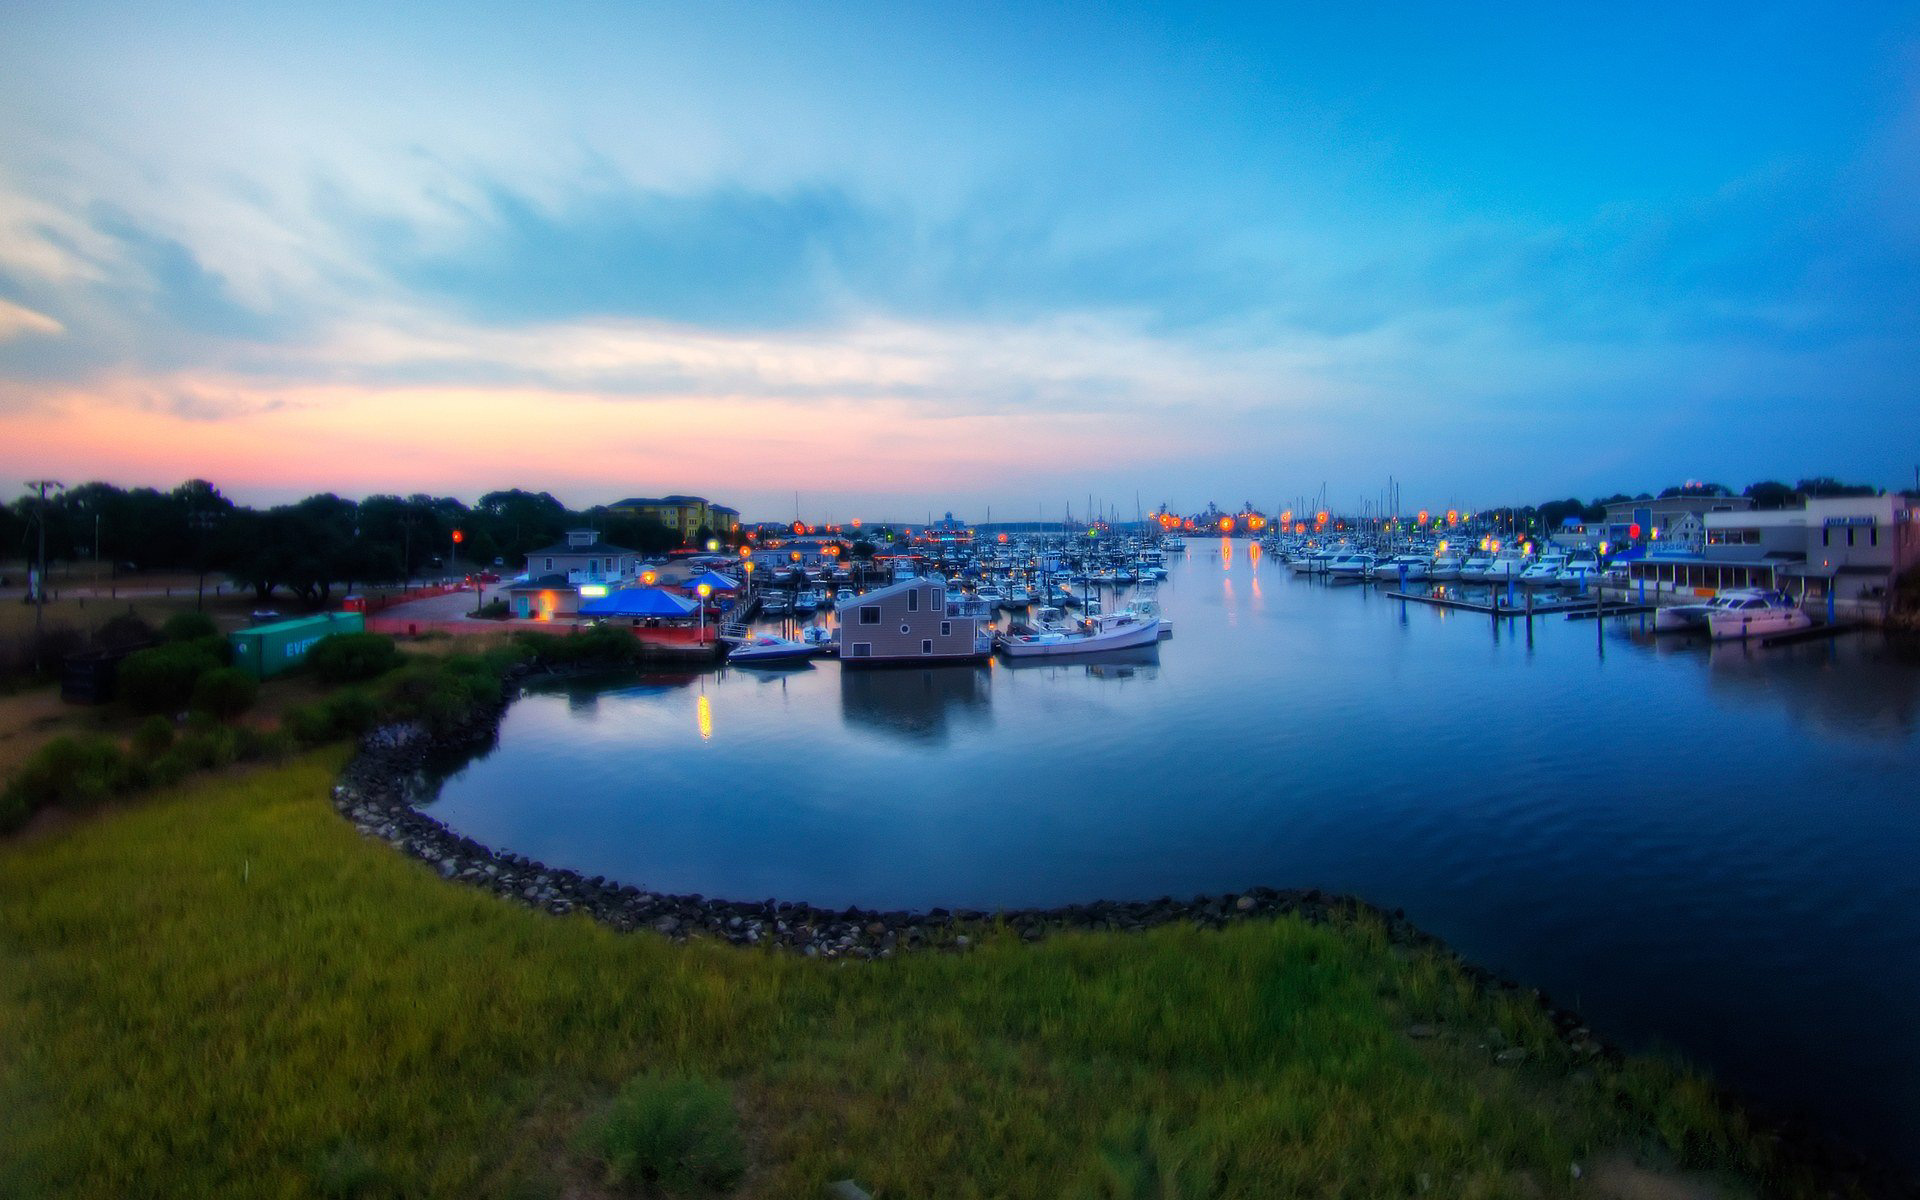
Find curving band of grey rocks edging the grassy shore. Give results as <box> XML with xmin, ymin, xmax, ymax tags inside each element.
<box><xmin>332</xmin><ymin>666</ymin><xmax>1920</xmax><ymax>1196</ymax></box>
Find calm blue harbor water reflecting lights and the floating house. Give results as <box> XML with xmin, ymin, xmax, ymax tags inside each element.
<box><xmin>432</xmin><ymin>541</ymin><xmax>1920</xmax><ymax>1165</ymax></box>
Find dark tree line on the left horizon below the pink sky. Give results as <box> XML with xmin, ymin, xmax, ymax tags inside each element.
<box><xmin>0</xmin><ymin>480</ymin><xmax>712</xmax><ymax>605</ymax></box>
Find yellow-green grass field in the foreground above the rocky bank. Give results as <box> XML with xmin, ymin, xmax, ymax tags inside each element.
<box><xmin>0</xmin><ymin>751</ymin><xmax>1820</xmax><ymax>1200</ymax></box>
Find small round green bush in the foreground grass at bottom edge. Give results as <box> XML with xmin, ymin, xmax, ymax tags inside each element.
<box><xmin>584</xmin><ymin>1071</ymin><xmax>747</xmax><ymax>1194</ymax></box>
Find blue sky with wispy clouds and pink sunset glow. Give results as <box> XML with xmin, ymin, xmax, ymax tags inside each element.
<box><xmin>0</xmin><ymin>0</ymin><xmax>1920</xmax><ymax>520</ymax></box>
